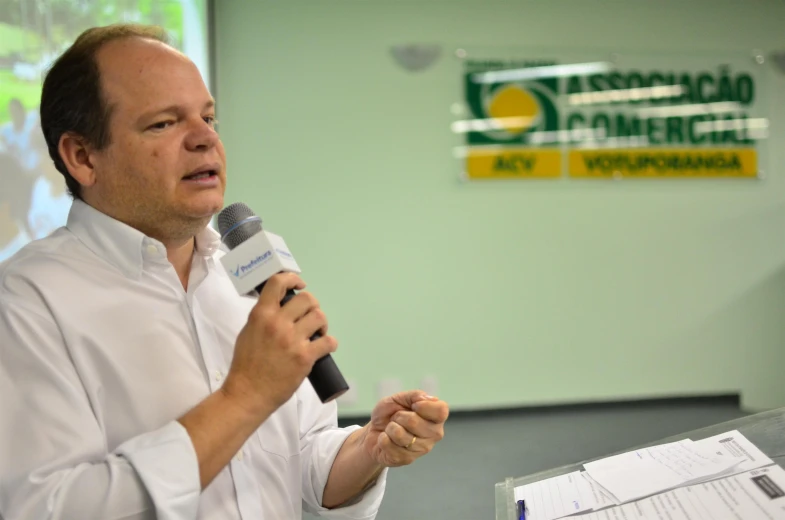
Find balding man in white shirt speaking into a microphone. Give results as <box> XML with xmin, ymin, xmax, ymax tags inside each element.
<box><xmin>0</xmin><ymin>25</ymin><xmax>448</xmax><ymax>520</ymax></box>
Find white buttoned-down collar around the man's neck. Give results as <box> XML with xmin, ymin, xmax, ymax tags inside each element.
<box><xmin>66</xmin><ymin>199</ymin><xmax>221</xmax><ymax>279</ymax></box>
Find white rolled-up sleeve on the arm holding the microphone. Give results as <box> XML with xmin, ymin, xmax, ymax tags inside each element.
<box><xmin>0</xmin><ymin>294</ymin><xmax>201</xmax><ymax>520</ymax></box>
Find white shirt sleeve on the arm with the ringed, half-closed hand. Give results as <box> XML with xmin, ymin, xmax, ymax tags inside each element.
<box><xmin>297</xmin><ymin>381</ymin><xmax>388</xmax><ymax>520</ymax></box>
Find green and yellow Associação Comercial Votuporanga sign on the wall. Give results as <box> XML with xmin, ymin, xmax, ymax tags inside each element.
<box><xmin>460</xmin><ymin>57</ymin><xmax>768</xmax><ymax>179</ymax></box>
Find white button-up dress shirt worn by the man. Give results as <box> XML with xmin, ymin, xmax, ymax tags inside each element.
<box><xmin>0</xmin><ymin>201</ymin><xmax>387</xmax><ymax>520</ymax></box>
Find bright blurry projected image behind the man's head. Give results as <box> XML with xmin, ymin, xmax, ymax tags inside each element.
<box><xmin>0</xmin><ymin>0</ymin><xmax>209</xmax><ymax>262</ymax></box>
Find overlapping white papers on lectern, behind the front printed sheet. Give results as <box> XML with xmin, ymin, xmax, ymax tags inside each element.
<box><xmin>514</xmin><ymin>430</ymin><xmax>773</xmax><ymax>520</ymax></box>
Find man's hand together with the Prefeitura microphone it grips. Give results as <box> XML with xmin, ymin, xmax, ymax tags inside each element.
<box><xmin>218</xmin><ymin>203</ymin><xmax>349</xmax><ymax>406</ymax></box>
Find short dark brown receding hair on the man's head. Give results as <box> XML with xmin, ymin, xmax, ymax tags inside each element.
<box><xmin>40</xmin><ymin>24</ymin><xmax>169</xmax><ymax>199</ymax></box>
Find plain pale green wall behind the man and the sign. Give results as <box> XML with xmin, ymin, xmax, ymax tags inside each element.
<box><xmin>215</xmin><ymin>0</ymin><xmax>785</xmax><ymax>415</ymax></box>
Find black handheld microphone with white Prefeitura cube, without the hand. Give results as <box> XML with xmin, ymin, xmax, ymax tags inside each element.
<box><xmin>218</xmin><ymin>202</ymin><xmax>349</xmax><ymax>403</ymax></box>
